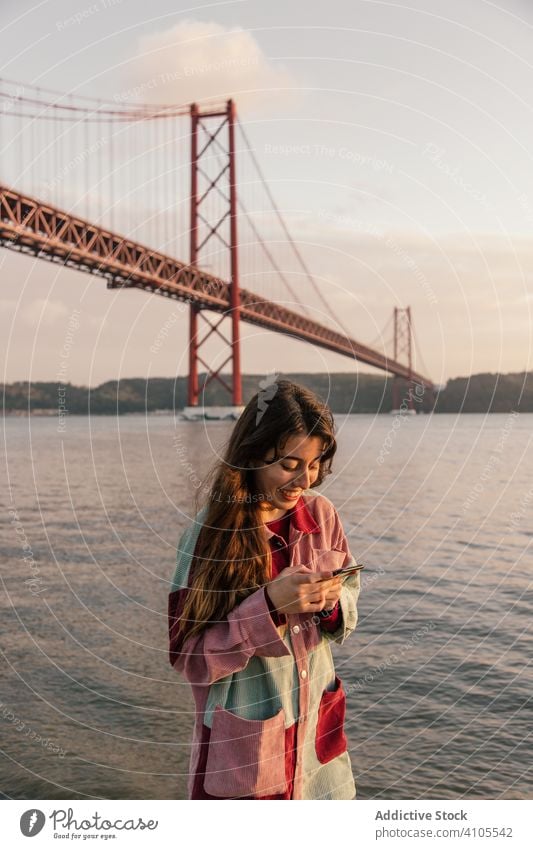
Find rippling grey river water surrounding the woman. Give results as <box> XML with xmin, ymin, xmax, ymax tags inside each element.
<box><xmin>0</xmin><ymin>413</ymin><xmax>533</xmax><ymax>799</ymax></box>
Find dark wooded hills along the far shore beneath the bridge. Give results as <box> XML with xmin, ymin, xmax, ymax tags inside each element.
<box><xmin>3</xmin><ymin>372</ymin><xmax>533</xmax><ymax>414</ymax></box>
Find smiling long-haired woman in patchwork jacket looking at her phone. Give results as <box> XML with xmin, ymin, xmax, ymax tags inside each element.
<box><xmin>168</xmin><ymin>380</ymin><xmax>360</xmax><ymax>799</ymax></box>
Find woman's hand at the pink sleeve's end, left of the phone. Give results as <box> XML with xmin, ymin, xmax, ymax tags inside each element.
<box><xmin>265</xmin><ymin>566</ymin><xmax>342</xmax><ymax>613</ymax></box>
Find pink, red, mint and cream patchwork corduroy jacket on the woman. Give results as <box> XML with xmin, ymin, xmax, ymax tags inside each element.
<box><xmin>168</xmin><ymin>490</ymin><xmax>360</xmax><ymax>799</ymax></box>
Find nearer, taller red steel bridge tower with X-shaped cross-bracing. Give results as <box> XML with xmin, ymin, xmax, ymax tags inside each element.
<box><xmin>183</xmin><ymin>100</ymin><xmax>244</xmax><ymax>418</ymax></box>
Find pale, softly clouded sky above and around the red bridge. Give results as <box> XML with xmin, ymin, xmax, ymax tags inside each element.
<box><xmin>0</xmin><ymin>0</ymin><xmax>533</xmax><ymax>386</ymax></box>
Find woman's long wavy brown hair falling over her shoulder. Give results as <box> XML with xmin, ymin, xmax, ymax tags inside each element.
<box><xmin>179</xmin><ymin>380</ymin><xmax>337</xmax><ymax>638</ymax></box>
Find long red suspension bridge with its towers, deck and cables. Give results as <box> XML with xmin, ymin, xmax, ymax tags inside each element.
<box><xmin>0</xmin><ymin>80</ymin><xmax>435</xmax><ymax>416</ymax></box>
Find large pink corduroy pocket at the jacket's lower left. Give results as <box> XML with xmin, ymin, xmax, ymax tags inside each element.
<box><xmin>204</xmin><ymin>705</ymin><xmax>287</xmax><ymax>798</ymax></box>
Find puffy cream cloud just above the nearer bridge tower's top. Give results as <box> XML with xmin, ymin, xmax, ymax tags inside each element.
<box><xmin>115</xmin><ymin>20</ymin><xmax>296</xmax><ymax>110</ymax></box>
